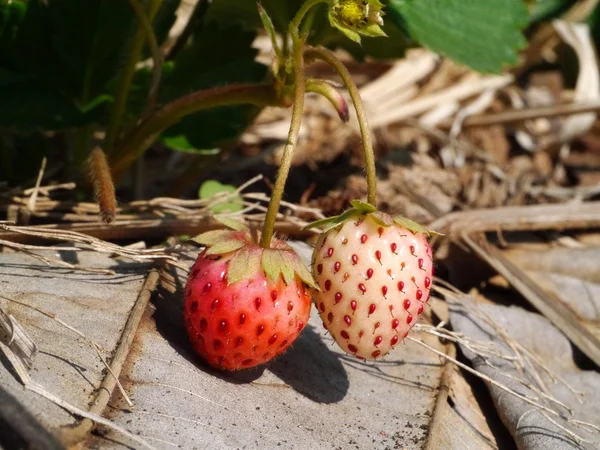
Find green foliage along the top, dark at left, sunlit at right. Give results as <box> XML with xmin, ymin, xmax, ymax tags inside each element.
<box><xmin>0</xmin><ymin>0</ymin><xmax>600</xmax><ymax>186</ymax></box>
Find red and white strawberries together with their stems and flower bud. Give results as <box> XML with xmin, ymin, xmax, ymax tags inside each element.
<box><xmin>184</xmin><ymin>0</ymin><xmax>433</xmax><ymax>370</ymax></box>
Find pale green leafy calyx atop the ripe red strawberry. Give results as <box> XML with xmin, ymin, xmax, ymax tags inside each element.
<box><xmin>190</xmin><ymin>216</ymin><xmax>317</xmax><ymax>288</ymax></box>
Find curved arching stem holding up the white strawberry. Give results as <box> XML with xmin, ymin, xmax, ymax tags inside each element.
<box><xmin>304</xmin><ymin>47</ymin><xmax>377</xmax><ymax>206</ymax></box>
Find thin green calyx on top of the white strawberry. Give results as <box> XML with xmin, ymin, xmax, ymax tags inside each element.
<box><xmin>304</xmin><ymin>200</ymin><xmax>440</xmax><ymax>236</ymax></box>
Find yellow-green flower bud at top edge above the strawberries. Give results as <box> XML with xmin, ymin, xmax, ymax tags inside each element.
<box><xmin>329</xmin><ymin>0</ymin><xmax>386</xmax><ymax>43</ymax></box>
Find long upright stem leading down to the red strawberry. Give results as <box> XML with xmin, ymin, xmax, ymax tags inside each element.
<box><xmin>260</xmin><ymin>0</ymin><xmax>327</xmax><ymax>248</ymax></box>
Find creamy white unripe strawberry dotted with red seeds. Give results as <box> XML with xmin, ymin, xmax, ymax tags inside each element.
<box><xmin>313</xmin><ymin>202</ymin><xmax>433</xmax><ymax>359</ymax></box>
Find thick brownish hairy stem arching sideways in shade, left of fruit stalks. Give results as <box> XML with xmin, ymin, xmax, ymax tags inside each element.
<box><xmin>111</xmin><ymin>84</ymin><xmax>289</xmax><ymax>177</ymax></box>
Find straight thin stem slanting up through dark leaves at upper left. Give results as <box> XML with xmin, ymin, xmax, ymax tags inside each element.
<box><xmin>103</xmin><ymin>0</ymin><xmax>162</xmax><ymax>156</ymax></box>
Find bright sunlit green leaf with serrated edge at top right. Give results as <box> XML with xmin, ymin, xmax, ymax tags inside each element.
<box><xmin>386</xmin><ymin>0</ymin><xmax>529</xmax><ymax>72</ymax></box>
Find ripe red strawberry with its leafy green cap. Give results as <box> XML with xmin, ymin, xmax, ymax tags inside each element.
<box><xmin>184</xmin><ymin>219</ymin><xmax>314</xmax><ymax>370</ymax></box>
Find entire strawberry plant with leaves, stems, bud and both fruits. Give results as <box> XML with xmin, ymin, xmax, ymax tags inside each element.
<box><xmin>0</xmin><ymin>0</ymin><xmax>580</xmax><ymax>369</ymax></box>
